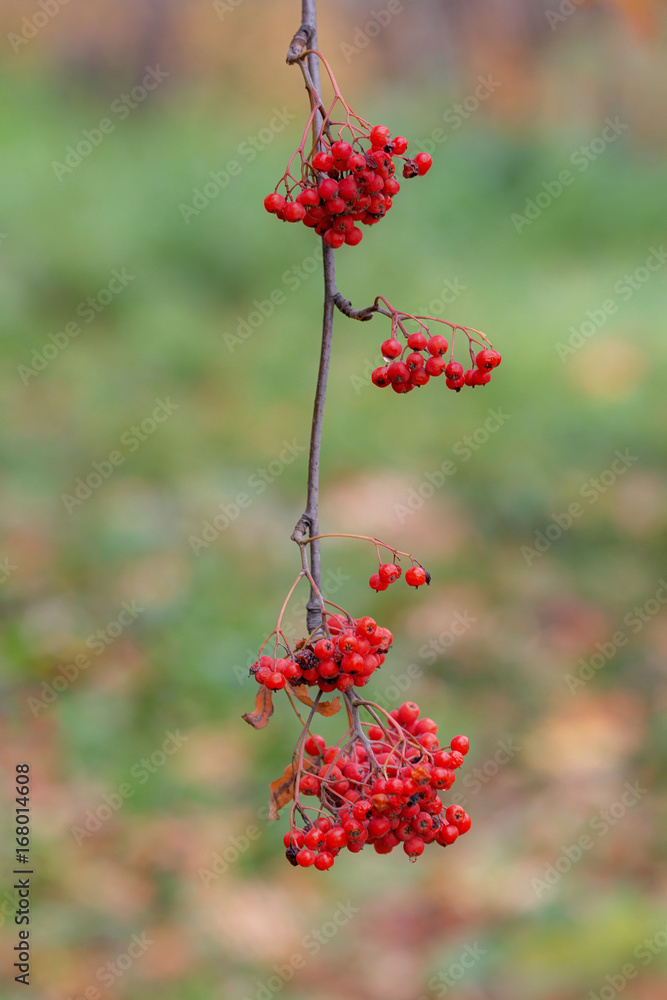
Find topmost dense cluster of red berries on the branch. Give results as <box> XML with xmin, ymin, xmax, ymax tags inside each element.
<box><xmin>264</xmin><ymin>125</ymin><xmax>433</xmax><ymax>249</ymax></box>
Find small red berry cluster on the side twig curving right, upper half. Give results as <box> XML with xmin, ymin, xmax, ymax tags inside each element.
<box><xmin>371</xmin><ymin>331</ymin><xmax>501</xmax><ymax>393</ymax></box>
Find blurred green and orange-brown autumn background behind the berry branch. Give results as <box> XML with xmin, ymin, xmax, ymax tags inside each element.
<box><xmin>0</xmin><ymin>0</ymin><xmax>667</xmax><ymax>1000</ymax></box>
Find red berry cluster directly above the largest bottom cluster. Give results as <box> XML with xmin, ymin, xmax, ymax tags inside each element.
<box><xmin>250</xmin><ymin>614</ymin><xmax>394</xmax><ymax>692</ymax></box>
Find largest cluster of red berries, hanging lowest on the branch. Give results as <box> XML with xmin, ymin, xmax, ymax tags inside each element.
<box><xmin>283</xmin><ymin>701</ymin><xmax>470</xmax><ymax>871</ymax></box>
